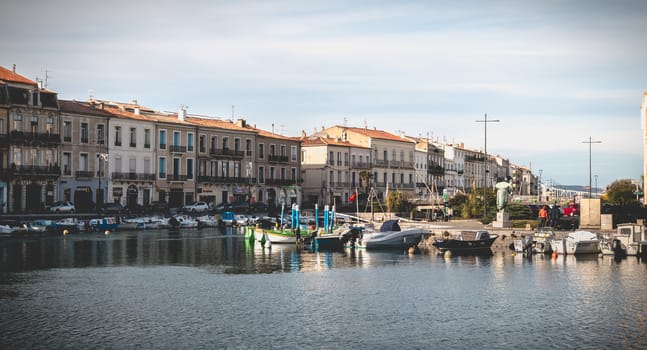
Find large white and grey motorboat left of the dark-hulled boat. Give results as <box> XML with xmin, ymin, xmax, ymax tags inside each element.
<box><xmin>349</xmin><ymin>220</ymin><xmax>429</xmax><ymax>249</ymax></box>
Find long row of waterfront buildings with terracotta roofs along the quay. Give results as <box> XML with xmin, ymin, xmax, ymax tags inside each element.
<box><xmin>0</xmin><ymin>67</ymin><xmax>537</xmax><ymax>213</ymax></box>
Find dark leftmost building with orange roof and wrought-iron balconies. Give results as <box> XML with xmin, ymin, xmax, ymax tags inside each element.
<box><xmin>0</xmin><ymin>66</ymin><xmax>61</xmax><ymax>213</ymax></box>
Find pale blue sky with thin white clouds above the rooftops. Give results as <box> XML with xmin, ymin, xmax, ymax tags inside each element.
<box><xmin>0</xmin><ymin>0</ymin><xmax>647</xmax><ymax>188</ymax></box>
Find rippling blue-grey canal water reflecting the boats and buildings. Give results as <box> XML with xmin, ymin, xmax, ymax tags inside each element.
<box><xmin>0</xmin><ymin>229</ymin><xmax>647</xmax><ymax>349</ymax></box>
